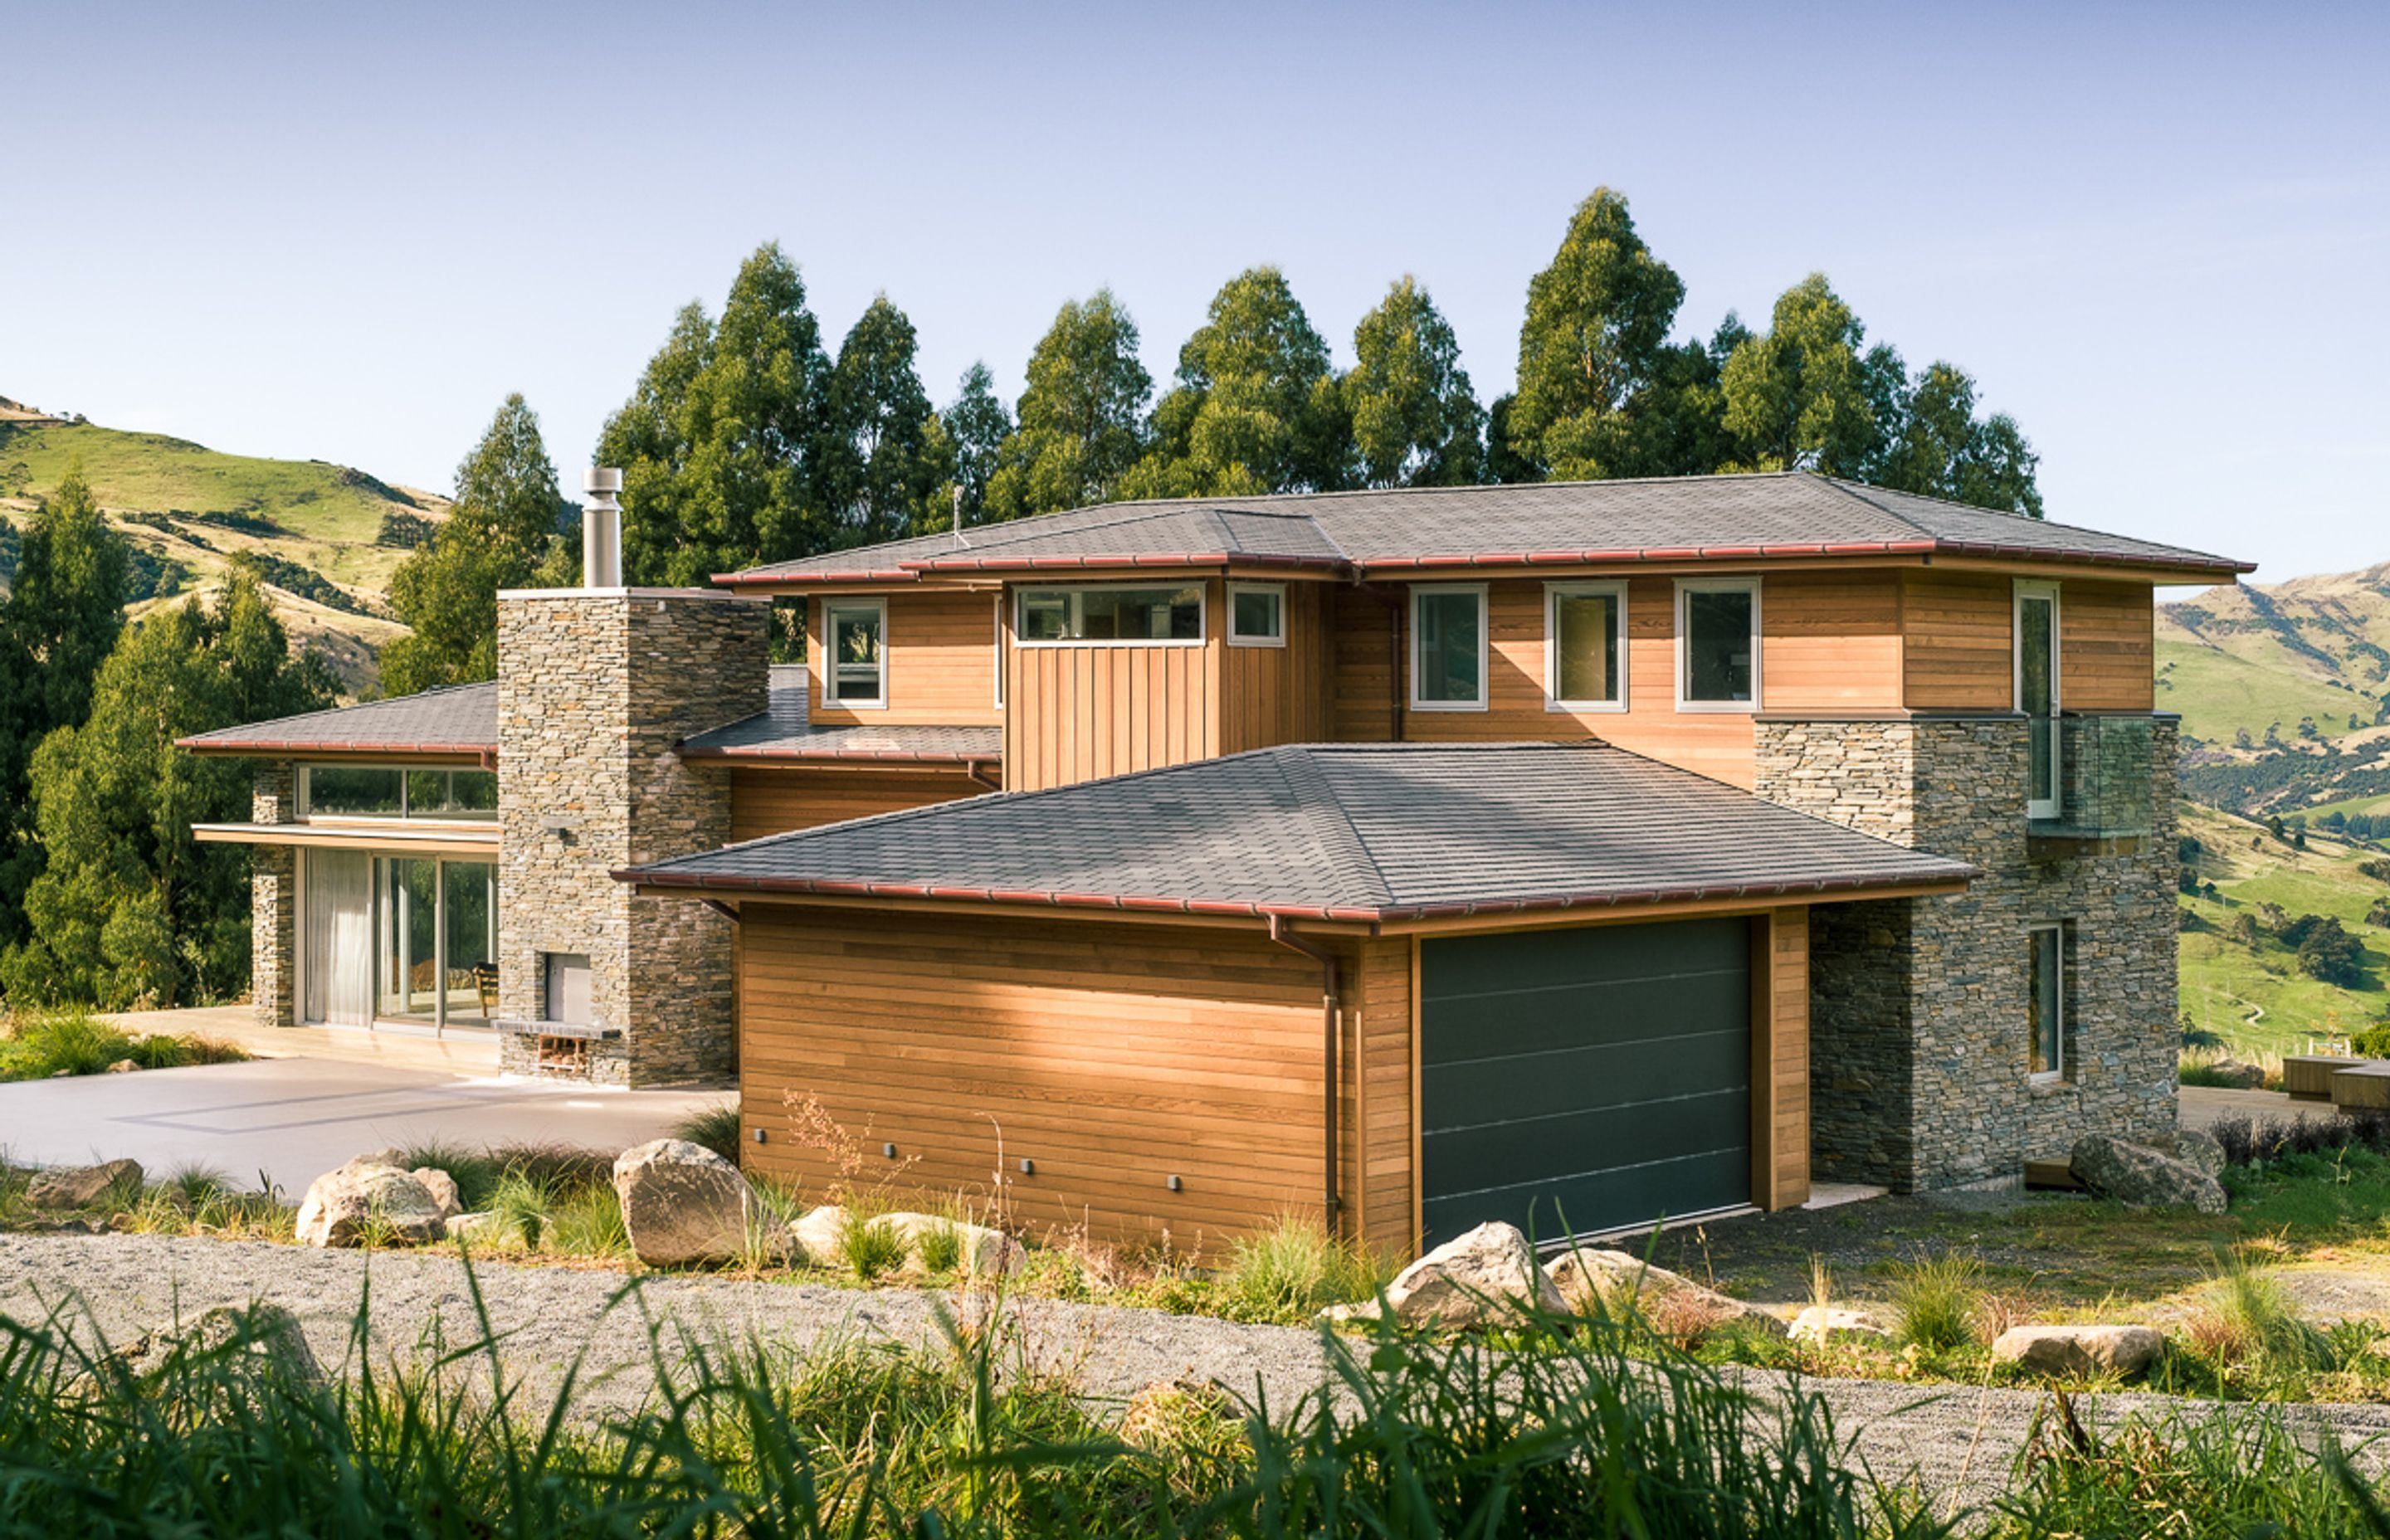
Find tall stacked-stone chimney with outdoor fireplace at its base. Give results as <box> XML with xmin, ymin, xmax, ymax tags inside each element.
<box><xmin>497</xmin><ymin>588</ymin><xmax>769</xmax><ymax>1085</ymax></box>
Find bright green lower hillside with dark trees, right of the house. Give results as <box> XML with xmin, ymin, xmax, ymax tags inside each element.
<box><xmin>2180</xmin><ymin>803</ymin><xmax>2390</xmax><ymax>1055</ymax></box>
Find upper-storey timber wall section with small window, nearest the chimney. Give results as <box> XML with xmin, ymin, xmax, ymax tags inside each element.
<box><xmin>806</xmin><ymin>588</ymin><xmax>1004</xmax><ymax>727</ymax></box>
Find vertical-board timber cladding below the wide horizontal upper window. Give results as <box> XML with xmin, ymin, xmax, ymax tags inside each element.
<box><xmin>1004</xmin><ymin>581</ymin><xmax>1226</xmax><ymax>792</ymax></box>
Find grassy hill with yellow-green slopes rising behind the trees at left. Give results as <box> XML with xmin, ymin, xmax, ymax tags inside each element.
<box><xmin>0</xmin><ymin>404</ymin><xmax>447</xmax><ymax>694</ymax></box>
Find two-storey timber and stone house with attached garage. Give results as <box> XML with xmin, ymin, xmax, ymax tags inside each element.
<box><xmin>177</xmin><ymin>474</ymin><xmax>2246</xmax><ymax>1248</ymax></box>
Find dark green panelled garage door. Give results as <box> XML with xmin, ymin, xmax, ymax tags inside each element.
<box><xmin>1420</xmin><ymin>921</ymin><xmax>1752</xmax><ymax>1246</ymax></box>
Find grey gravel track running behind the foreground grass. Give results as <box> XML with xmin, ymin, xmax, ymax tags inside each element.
<box><xmin>0</xmin><ymin>1234</ymin><xmax>2390</xmax><ymax>1502</ymax></box>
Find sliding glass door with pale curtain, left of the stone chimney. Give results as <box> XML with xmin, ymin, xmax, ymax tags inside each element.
<box><xmin>301</xmin><ymin>851</ymin><xmax>497</xmax><ymax>1031</ymax></box>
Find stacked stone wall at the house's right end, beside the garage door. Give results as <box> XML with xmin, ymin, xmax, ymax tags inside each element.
<box><xmin>1757</xmin><ymin>715</ymin><xmax>2178</xmax><ymax>1191</ymax></box>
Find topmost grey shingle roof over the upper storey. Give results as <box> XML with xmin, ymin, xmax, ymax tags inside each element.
<box><xmin>717</xmin><ymin>474</ymin><xmax>2249</xmax><ymax>583</ymax></box>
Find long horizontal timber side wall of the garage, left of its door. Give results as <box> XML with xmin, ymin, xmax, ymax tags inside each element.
<box><xmin>739</xmin><ymin>902</ymin><xmax>1338</xmax><ymax>1248</ymax></box>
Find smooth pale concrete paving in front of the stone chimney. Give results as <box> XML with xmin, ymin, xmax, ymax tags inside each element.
<box><xmin>0</xmin><ymin>1060</ymin><xmax>729</xmax><ymax>1198</ymax></box>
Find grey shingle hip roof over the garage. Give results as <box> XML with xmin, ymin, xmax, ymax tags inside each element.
<box><xmin>614</xmin><ymin>741</ymin><xmax>1977</xmax><ymax>921</ymax></box>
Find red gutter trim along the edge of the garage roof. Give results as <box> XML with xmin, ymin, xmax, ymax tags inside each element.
<box><xmin>612</xmin><ymin>865</ymin><xmax>1983</xmax><ymax>923</ymax></box>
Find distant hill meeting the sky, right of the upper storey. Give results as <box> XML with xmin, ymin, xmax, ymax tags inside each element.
<box><xmin>2158</xmin><ymin>564</ymin><xmax>2390</xmax><ymax>816</ymax></box>
